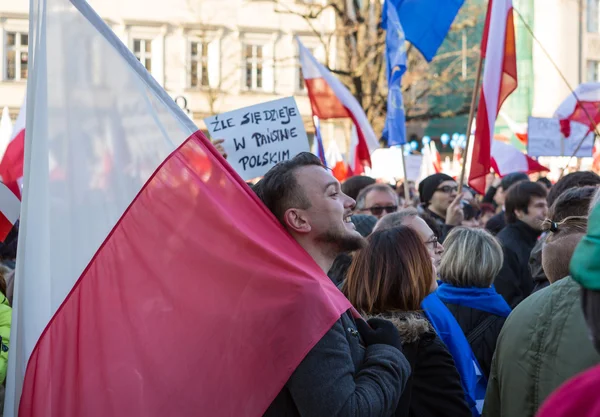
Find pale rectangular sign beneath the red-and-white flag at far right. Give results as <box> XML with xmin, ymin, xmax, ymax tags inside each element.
<box><xmin>527</xmin><ymin>117</ymin><xmax>595</xmax><ymax>158</ymax></box>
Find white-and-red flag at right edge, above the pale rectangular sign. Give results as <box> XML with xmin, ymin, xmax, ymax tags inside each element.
<box><xmin>554</xmin><ymin>83</ymin><xmax>600</xmax><ymax>137</ymax></box>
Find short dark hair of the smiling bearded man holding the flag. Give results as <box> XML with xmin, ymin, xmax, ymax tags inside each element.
<box><xmin>253</xmin><ymin>152</ymin><xmax>325</xmax><ymax>226</ymax></box>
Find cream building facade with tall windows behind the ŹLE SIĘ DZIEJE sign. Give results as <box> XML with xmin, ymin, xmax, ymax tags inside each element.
<box><xmin>0</xmin><ymin>0</ymin><xmax>336</xmax><ymax>133</ymax></box>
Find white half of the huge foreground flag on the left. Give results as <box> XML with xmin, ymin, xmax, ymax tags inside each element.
<box><xmin>4</xmin><ymin>0</ymin><xmax>196</xmax><ymax>417</ymax></box>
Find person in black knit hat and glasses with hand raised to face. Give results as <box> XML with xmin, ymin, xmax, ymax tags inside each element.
<box><xmin>419</xmin><ymin>174</ymin><xmax>464</xmax><ymax>242</ymax></box>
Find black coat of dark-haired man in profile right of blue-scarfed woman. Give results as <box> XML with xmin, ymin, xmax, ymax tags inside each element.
<box><xmin>494</xmin><ymin>221</ymin><xmax>541</xmax><ymax>309</ymax></box>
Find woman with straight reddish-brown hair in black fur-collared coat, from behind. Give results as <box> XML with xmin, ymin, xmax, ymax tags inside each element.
<box><xmin>342</xmin><ymin>226</ymin><xmax>472</xmax><ymax>417</ymax></box>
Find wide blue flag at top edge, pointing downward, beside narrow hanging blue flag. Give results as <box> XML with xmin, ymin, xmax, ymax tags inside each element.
<box><xmin>386</xmin><ymin>0</ymin><xmax>464</xmax><ymax>62</ymax></box>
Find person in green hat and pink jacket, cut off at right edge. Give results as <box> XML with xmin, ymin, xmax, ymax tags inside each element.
<box><xmin>538</xmin><ymin>200</ymin><xmax>600</xmax><ymax>417</ymax></box>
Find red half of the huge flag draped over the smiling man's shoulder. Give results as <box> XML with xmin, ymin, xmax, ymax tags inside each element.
<box><xmin>19</xmin><ymin>133</ymin><xmax>350</xmax><ymax>417</ymax></box>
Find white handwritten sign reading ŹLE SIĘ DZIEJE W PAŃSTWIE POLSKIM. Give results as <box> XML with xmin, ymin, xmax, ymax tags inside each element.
<box><xmin>204</xmin><ymin>97</ymin><xmax>309</xmax><ymax>180</ymax></box>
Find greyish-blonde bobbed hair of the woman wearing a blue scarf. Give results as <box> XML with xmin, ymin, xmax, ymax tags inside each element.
<box><xmin>438</xmin><ymin>227</ymin><xmax>504</xmax><ymax>288</ymax></box>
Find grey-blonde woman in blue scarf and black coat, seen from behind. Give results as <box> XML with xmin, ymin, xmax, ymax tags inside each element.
<box><xmin>437</xmin><ymin>227</ymin><xmax>511</xmax><ymax>378</ymax></box>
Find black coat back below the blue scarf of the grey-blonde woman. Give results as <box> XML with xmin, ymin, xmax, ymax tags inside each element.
<box><xmin>446</xmin><ymin>303</ymin><xmax>506</xmax><ymax>378</ymax></box>
